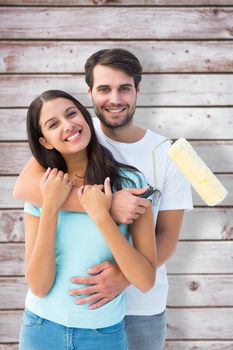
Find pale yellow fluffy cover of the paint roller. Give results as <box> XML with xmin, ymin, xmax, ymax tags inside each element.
<box><xmin>168</xmin><ymin>138</ymin><xmax>227</xmax><ymax>206</ymax></box>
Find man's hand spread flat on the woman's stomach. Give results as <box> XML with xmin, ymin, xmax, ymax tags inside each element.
<box><xmin>69</xmin><ymin>261</ymin><xmax>129</xmax><ymax>309</ymax></box>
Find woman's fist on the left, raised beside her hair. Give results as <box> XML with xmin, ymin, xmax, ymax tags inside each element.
<box><xmin>40</xmin><ymin>168</ymin><xmax>72</xmax><ymax>210</ymax></box>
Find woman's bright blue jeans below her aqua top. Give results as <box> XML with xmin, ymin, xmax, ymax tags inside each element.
<box><xmin>19</xmin><ymin>309</ymin><xmax>128</xmax><ymax>350</ymax></box>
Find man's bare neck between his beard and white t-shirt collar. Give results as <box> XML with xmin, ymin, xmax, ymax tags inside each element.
<box><xmin>100</xmin><ymin>123</ymin><xmax>146</xmax><ymax>143</ymax></box>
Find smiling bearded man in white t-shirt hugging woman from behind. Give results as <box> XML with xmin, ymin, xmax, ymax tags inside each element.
<box><xmin>15</xmin><ymin>49</ymin><xmax>192</xmax><ymax>350</ymax></box>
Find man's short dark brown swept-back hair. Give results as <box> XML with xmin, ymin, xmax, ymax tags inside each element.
<box><xmin>85</xmin><ymin>49</ymin><xmax>142</xmax><ymax>89</ymax></box>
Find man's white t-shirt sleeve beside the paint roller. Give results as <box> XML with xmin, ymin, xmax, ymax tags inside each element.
<box><xmin>159</xmin><ymin>157</ymin><xmax>193</xmax><ymax>211</ymax></box>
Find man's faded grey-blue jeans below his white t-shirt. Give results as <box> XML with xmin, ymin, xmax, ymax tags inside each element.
<box><xmin>125</xmin><ymin>311</ymin><xmax>167</xmax><ymax>350</ymax></box>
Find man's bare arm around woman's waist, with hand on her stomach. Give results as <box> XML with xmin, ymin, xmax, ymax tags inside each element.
<box><xmin>70</xmin><ymin>206</ymin><xmax>184</xmax><ymax>309</ymax></box>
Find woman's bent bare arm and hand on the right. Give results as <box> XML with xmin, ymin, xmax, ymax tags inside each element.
<box><xmin>78</xmin><ymin>181</ymin><xmax>156</xmax><ymax>292</ymax></box>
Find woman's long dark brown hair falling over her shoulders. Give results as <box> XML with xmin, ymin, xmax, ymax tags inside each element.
<box><xmin>27</xmin><ymin>90</ymin><xmax>144</xmax><ymax>190</ymax></box>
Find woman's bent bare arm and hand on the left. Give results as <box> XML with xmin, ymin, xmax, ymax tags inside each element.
<box><xmin>25</xmin><ymin>169</ymin><xmax>72</xmax><ymax>297</ymax></box>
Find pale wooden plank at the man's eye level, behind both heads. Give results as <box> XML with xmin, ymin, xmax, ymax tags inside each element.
<box><xmin>0</xmin><ymin>74</ymin><xmax>233</xmax><ymax>108</ymax></box>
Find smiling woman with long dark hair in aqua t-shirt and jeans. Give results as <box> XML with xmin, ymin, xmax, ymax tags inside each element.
<box><xmin>20</xmin><ymin>90</ymin><xmax>156</xmax><ymax>350</ymax></box>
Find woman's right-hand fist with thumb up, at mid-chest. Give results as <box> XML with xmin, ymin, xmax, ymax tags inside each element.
<box><xmin>78</xmin><ymin>178</ymin><xmax>112</xmax><ymax>220</ymax></box>
